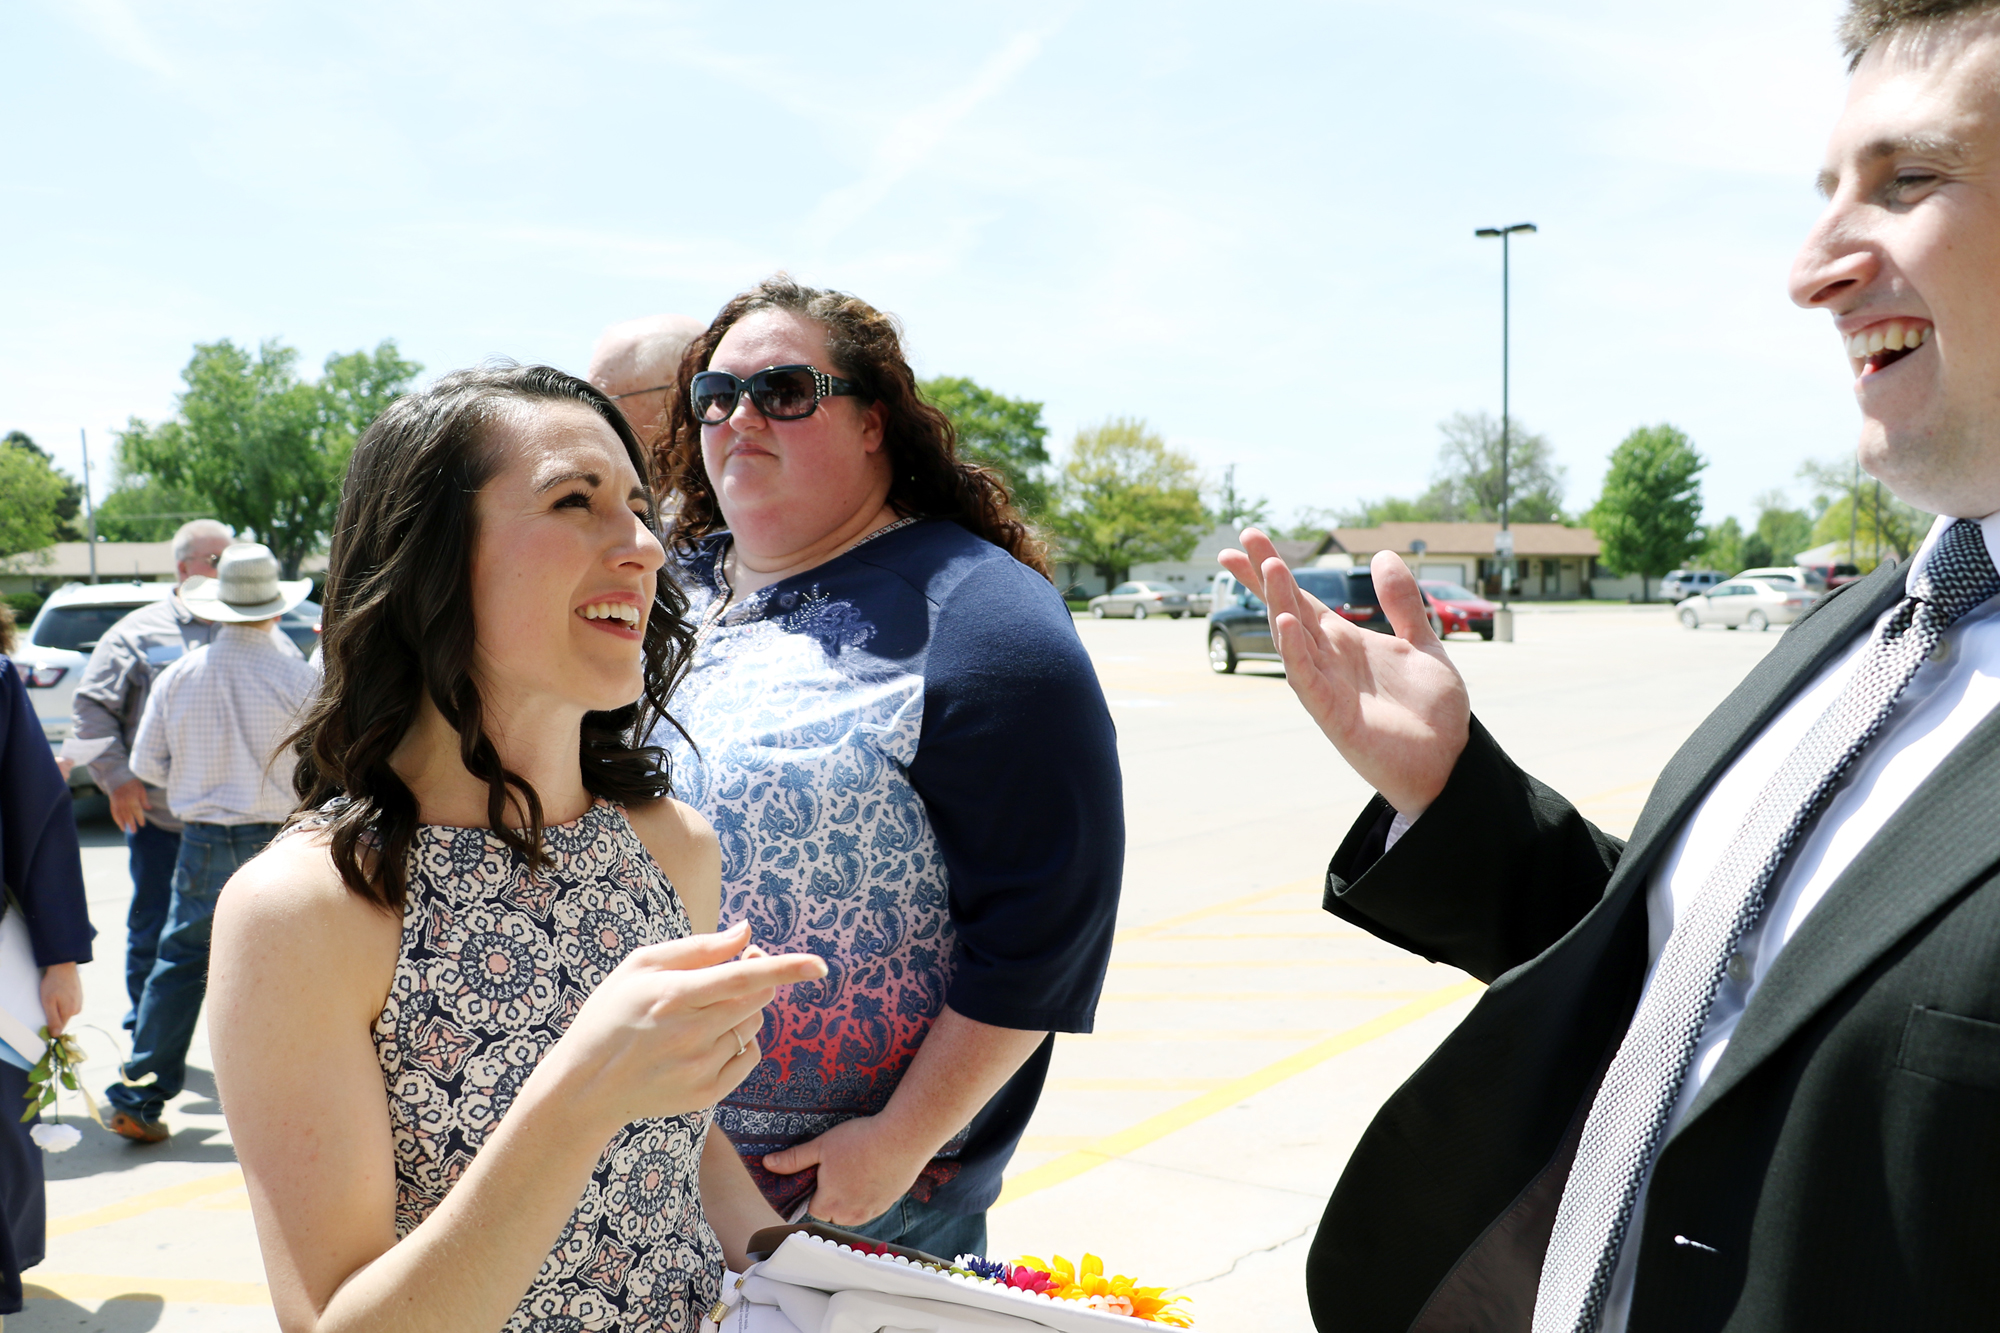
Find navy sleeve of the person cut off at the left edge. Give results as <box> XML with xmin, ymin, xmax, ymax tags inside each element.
<box><xmin>0</xmin><ymin>656</ymin><xmax>96</xmax><ymax>967</ymax></box>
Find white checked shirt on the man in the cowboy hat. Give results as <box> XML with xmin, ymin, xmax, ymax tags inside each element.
<box><xmin>132</xmin><ymin>624</ymin><xmax>320</xmax><ymax>825</ymax></box>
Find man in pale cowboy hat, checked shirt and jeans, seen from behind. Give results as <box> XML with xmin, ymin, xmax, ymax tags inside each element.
<box><xmin>104</xmin><ymin>542</ymin><xmax>318</xmax><ymax>1143</ymax></box>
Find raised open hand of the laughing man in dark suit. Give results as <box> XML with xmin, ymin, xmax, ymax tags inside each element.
<box><xmin>1222</xmin><ymin>528</ymin><xmax>1472</xmax><ymax>819</ymax></box>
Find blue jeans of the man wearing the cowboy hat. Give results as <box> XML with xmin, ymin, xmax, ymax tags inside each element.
<box><xmin>104</xmin><ymin>825</ymin><xmax>278</xmax><ymax>1121</ymax></box>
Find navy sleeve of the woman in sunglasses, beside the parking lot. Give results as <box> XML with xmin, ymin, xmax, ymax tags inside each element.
<box><xmin>910</xmin><ymin>560</ymin><xmax>1124</xmax><ymax>1033</ymax></box>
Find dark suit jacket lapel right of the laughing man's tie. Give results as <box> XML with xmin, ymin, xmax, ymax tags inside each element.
<box><xmin>1686</xmin><ymin>676</ymin><xmax>2000</xmax><ymax>1121</ymax></box>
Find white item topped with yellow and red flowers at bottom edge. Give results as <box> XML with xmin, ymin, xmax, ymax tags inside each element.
<box><xmin>712</xmin><ymin>1223</ymin><xmax>1194</xmax><ymax>1333</ymax></box>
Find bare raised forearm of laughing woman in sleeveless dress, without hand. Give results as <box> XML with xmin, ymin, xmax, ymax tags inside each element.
<box><xmin>312</xmin><ymin>1079</ymin><xmax>608</xmax><ymax>1333</ymax></box>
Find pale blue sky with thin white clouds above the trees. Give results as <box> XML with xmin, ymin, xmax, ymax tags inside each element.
<box><xmin>0</xmin><ymin>0</ymin><xmax>1856</xmax><ymax>518</ymax></box>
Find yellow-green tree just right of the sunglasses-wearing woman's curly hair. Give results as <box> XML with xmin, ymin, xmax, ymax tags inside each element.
<box><xmin>1050</xmin><ymin>416</ymin><xmax>1210</xmax><ymax>582</ymax></box>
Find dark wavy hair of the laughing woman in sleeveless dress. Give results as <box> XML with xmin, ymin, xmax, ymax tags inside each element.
<box><xmin>284</xmin><ymin>364</ymin><xmax>694</xmax><ymax>911</ymax></box>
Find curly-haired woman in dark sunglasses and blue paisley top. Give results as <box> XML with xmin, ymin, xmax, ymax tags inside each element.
<box><xmin>654</xmin><ymin>274</ymin><xmax>1124</xmax><ymax>1257</ymax></box>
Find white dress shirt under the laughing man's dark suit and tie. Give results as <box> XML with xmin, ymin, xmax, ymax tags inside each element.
<box><xmin>1600</xmin><ymin>514</ymin><xmax>2000</xmax><ymax>1333</ymax></box>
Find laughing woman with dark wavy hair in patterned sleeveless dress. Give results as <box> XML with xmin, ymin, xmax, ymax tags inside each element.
<box><xmin>208</xmin><ymin>366</ymin><xmax>824</xmax><ymax>1333</ymax></box>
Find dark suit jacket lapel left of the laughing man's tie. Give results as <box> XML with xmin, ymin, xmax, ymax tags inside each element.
<box><xmin>1606</xmin><ymin>564</ymin><xmax>1906</xmax><ymax>893</ymax></box>
